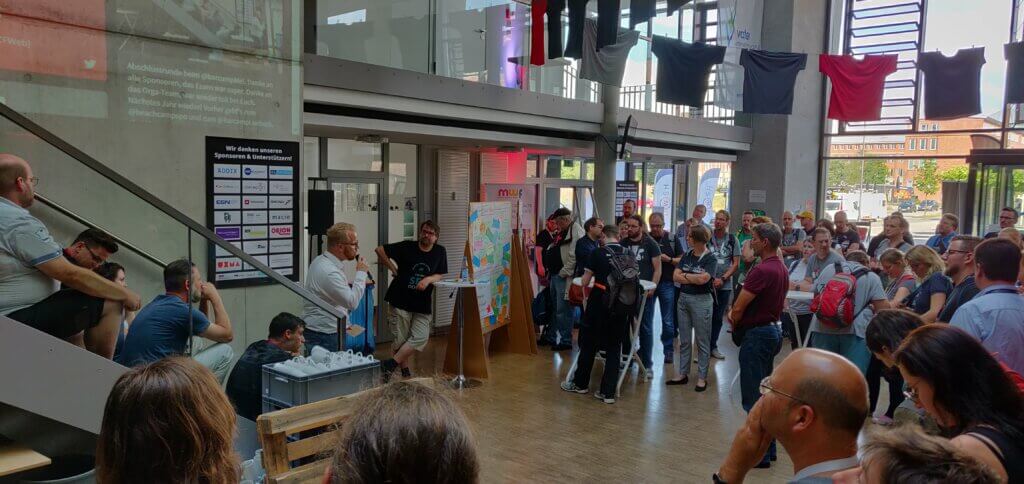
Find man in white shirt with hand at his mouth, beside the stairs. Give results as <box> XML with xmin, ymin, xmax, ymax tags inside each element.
<box><xmin>302</xmin><ymin>223</ymin><xmax>370</xmax><ymax>353</ymax></box>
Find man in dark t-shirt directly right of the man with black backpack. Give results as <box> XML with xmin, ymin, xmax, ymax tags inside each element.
<box><xmin>623</xmin><ymin>211</ymin><xmax>662</xmax><ymax>380</ymax></box>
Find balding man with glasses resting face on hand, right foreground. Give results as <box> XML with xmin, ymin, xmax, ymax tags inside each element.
<box><xmin>714</xmin><ymin>349</ymin><xmax>868</xmax><ymax>484</ymax></box>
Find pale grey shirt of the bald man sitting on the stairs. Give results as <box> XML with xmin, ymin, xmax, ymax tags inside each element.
<box><xmin>0</xmin><ymin>197</ymin><xmax>60</xmax><ymax>315</ymax></box>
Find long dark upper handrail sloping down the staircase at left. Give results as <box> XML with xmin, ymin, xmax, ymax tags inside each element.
<box><xmin>0</xmin><ymin>102</ymin><xmax>344</xmax><ymax>323</ymax></box>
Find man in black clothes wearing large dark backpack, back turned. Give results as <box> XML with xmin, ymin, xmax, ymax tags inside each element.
<box><xmin>561</xmin><ymin>225</ymin><xmax>633</xmax><ymax>403</ymax></box>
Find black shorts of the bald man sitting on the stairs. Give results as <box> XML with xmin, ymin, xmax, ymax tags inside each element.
<box><xmin>7</xmin><ymin>289</ymin><xmax>105</xmax><ymax>340</ymax></box>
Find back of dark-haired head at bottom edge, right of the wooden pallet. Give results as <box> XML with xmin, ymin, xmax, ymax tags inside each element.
<box><xmin>324</xmin><ymin>382</ymin><xmax>480</xmax><ymax>484</ymax></box>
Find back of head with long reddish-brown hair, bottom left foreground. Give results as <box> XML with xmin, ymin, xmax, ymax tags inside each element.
<box><xmin>96</xmin><ymin>356</ymin><xmax>241</xmax><ymax>484</ymax></box>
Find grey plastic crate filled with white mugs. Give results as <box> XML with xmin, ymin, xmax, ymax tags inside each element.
<box><xmin>263</xmin><ymin>361</ymin><xmax>381</xmax><ymax>411</ymax></box>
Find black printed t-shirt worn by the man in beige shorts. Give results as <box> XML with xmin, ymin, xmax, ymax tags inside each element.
<box><xmin>384</xmin><ymin>240</ymin><xmax>447</xmax><ymax>314</ymax></box>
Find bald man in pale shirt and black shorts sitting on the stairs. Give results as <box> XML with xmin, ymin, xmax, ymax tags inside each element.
<box><xmin>0</xmin><ymin>153</ymin><xmax>141</xmax><ymax>358</ymax></box>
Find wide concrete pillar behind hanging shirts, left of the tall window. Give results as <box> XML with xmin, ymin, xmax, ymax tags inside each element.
<box><xmin>731</xmin><ymin>0</ymin><xmax>827</xmax><ymax>221</ymax></box>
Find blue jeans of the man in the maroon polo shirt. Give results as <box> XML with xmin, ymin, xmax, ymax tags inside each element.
<box><xmin>739</xmin><ymin>324</ymin><xmax>782</xmax><ymax>464</ymax></box>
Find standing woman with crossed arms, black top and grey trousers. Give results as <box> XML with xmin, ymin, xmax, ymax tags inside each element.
<box><xmin>666</xmin><ymin>226</ymin><xmax>718</xmax><ymax>392</ymax></box>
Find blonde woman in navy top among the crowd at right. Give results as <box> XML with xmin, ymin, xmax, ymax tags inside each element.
<box><xmin>897</xmin><ymin>246</ymin><xmax>953</xmax><ymax>323</ymax></box>
